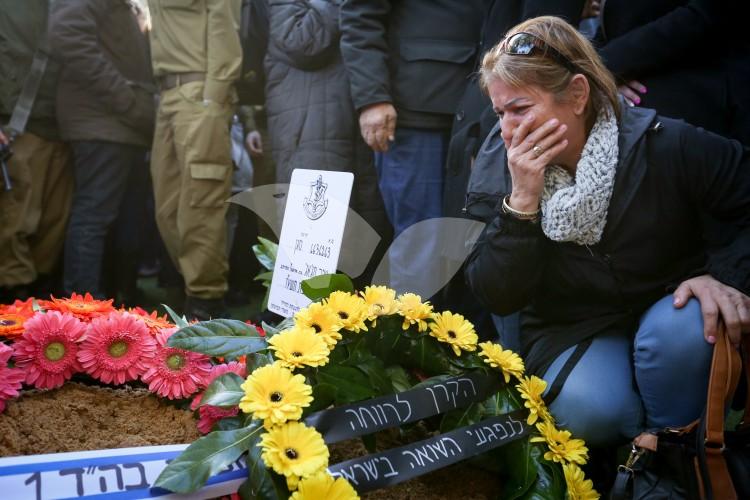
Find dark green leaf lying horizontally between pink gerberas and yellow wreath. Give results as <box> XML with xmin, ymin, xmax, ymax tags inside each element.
<box><xmin>167</xmin><ymin>319</ymin><xmax>268</xmax><ymax>359</ymax></box>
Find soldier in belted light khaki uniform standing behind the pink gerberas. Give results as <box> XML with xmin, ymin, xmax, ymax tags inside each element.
<box><xmin>149</xmin><ymin>0</ymin><xmax>242</xmax><ymax>320</ymax></box>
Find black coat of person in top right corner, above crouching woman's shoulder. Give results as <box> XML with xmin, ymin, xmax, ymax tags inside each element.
<box><xmin>597</xmin><ymin>0</ymin><xmax>750</xmax><ymax>144</ymax></box>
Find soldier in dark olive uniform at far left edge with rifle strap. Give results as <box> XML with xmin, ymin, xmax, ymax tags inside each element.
<box><xmin>0</xmin><ymin>0</ymin><xmax>73</xmax><ymax>303</ymax></box>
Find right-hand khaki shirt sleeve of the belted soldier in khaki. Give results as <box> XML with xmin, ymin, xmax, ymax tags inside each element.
<box><xmin>203</xmin><ymin>0</ymin><xmax>242</xmax><ymax>103</ymax></box>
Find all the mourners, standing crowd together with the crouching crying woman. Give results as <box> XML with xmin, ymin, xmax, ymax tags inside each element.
<box><xmin>0</xmin><ymin>0</ymin><xmax>750</xmax><ymax>494</ymax></box>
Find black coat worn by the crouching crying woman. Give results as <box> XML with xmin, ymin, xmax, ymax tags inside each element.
<box><xmin>466</xmin><ymin>103</ymin><xmax>750</xmax><ymax>373</ymax></box>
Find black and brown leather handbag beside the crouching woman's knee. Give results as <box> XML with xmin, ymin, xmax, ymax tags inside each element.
<box><xmin>610</xmin><ymin>327</ymin><xmax>750</xmax><ymax>500</ymax></box>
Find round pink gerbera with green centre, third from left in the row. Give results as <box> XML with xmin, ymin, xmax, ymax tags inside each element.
<box><xmin>78</xmin><ymin>312</ymin><xmax>156</xmax><ymax>384</ymax></box>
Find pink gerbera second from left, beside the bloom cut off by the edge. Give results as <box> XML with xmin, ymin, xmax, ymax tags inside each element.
<box><xmin>13</xmin><ymin>311</ymin><xmax>86</xmax><ymax>389</ymax></box>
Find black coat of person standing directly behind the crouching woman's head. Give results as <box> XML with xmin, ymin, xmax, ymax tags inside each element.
<box><xmin>443</xmin><ymin>0</ymin><xmax>584</xmax><ymax>217</ymax></box>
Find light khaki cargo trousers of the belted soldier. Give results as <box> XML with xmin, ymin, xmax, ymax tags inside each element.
<box><xmin>151</xmin><ymin>82</ymin><xmax>232</xmax><ymax>299</ymax></box>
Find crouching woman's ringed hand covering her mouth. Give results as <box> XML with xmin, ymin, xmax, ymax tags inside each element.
<box><xmin>502</xmin><ymin>114</ymin><xmax>568</xmax><ymax>212</ymax></box>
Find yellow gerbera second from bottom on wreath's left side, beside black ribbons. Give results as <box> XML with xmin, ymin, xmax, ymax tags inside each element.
<box><xmin>260</xmin><ymin>422</ymin><xmax>328</xmax><ymax>479</ymax></box>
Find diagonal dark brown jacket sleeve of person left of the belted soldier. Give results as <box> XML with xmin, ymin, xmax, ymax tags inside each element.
<box><xmin>49</xmin><ymin>0</ymin><xmax>136</xmax><ymax>113</ymax></box>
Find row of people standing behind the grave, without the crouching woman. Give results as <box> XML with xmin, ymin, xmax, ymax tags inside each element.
<box><xmin>0</xmin><ymin>0</ymin><xmax>750</xmax><ymax>316</ymax></box>
